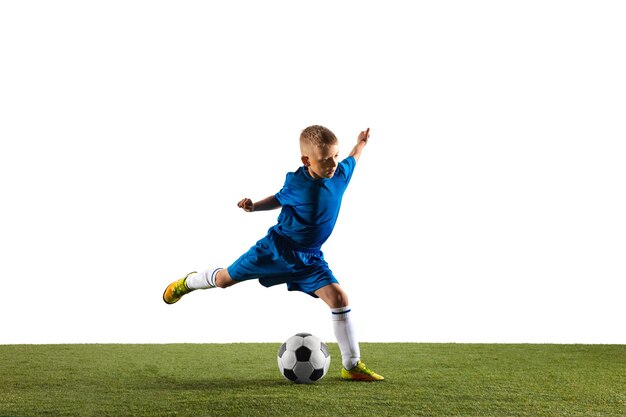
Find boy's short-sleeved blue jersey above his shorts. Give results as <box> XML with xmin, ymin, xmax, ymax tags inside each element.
<box><xmin>272</xmin><ymin>156</ymin><xmax>356</xmax><ymax>251</ymax></box>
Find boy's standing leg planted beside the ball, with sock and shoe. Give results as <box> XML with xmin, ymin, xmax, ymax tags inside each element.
<box><xmin>315</xmin><ymin>284</ymin><xmax>385</xmax><ymax>381</ymax></box>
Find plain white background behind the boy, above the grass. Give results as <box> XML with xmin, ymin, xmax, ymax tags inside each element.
<box><xmin>0</xmin><ymin>1</ymin><xmax>626</xmax><ymax>344</ymax></box>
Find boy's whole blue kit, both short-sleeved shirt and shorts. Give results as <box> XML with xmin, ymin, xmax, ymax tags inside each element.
<box><xmin>228</xmin><ymin>156</ymin><xmax>356</xmax><ymax>297</ymax></box>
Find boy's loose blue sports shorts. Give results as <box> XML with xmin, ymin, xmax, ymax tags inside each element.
<box><xmin>228</xmin><ymin>229</ymin><xmax>339</xmax><ymax>297</ymax></box>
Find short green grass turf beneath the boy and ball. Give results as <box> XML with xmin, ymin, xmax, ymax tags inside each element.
<box><xmin>0</xmin><ymin>343</ymin><xmax>626</xmax><ymax>417</ymax></box>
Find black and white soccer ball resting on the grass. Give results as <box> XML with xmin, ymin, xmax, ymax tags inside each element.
<box><xmin>278</xmin><ymin>333</ymin><xmax>330</xmax><ymax>384</ymax></box>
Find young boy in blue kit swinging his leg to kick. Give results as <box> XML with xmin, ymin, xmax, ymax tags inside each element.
<box><xmin>163</xmin><ymin>126</ymin><xmax>384</xmax><ymax>381</ymax></box>
